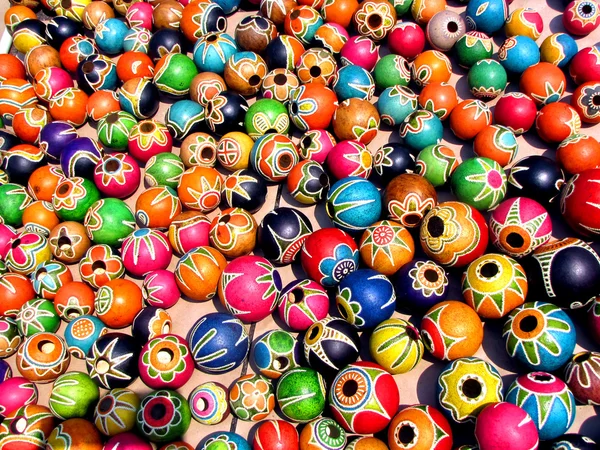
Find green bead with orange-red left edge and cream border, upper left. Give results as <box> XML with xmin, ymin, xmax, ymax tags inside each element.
<box><xmin>154</xmin><ymin>53</ymin><xmax>198</xmax><ymax>97</ymax></box>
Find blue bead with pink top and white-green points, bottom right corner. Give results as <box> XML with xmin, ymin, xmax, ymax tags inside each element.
<box><xmin>506</xmin><ymin>372</ymin><xmax>575</xmax><ymax>441</ymax></box>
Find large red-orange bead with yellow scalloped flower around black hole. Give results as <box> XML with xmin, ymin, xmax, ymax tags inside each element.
<box><xmin>419</xmin><ymin>202</ymin><xmax>488</xmax><ymax>267</ymax></box>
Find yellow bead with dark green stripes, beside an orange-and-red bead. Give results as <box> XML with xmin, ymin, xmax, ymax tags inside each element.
<box><xmin>369</xmin><ymin>318</ymin><xmax>424</xmax><ymax>375</ymax></box>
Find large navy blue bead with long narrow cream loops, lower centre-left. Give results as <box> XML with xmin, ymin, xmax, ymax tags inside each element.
<box><xmin>187</xmin><ymin>313</ymin><xmax>250</xmax><ymax>373</ymax></box>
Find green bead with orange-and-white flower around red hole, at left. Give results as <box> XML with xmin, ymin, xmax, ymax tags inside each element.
<box><xmin>52</xmin><ymin>177</ymin><xmax>100</xmax><ymax>222</ymax></box>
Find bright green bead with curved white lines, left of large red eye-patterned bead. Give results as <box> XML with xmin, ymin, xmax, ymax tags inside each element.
<box><xmin>275</xmin><ymin>367</ymin><xmax>326</xmax><ymax>422</ymax></box>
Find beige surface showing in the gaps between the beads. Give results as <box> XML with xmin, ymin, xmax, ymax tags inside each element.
<box><xmin>0</xmin><ymin>0</ymin><xmax>600</xmax><ymax>446</ymax></box>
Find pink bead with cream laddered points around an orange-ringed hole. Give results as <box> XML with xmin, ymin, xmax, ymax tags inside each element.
<box><xmin>489</xmin><ymin>197</ymin><xmax>552</xmax><ymax>258</ymax></box>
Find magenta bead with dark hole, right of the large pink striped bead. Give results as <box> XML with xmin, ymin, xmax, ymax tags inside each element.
<box><xmin>277</xmin><ymin>279</ymin><xmax>329</xmax><ymax>331</ymax></box>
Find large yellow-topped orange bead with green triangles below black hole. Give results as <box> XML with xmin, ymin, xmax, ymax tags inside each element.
<box><xmin>462</xmin><ymin>253</ymin><xmax>527</xmax><ymax>319</ymax></box>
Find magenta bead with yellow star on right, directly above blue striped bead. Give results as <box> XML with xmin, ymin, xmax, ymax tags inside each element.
<box><xmin>327</xmin><ymin>141</ymin><xmax>373</xmax><ymax>180</ymax></box>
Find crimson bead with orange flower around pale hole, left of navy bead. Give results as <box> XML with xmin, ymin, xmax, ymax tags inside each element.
<box><xmin>138</xmin><ymin>334</ymin><xmax>194</xmax><ymax>389</ymax></box>
